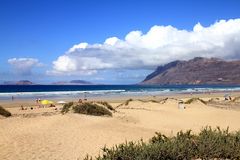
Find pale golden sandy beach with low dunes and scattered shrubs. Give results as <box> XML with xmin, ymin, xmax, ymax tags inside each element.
<box><xmin>0</xmin><ymin>92</ymin><xmax>240</xmax><ymax>160</ymax></box>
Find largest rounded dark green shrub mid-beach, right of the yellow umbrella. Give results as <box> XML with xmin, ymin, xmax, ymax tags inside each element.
<box><xmin>73</xmin><ymin>103</ymin><xmax>112</xmax><ymax>116</ymax></box>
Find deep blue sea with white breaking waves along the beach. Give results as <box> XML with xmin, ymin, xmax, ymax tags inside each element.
<box><xmin>0</xmin><ymin>85</ymin><xmax>240</xmax><ymax>100</ymax></box>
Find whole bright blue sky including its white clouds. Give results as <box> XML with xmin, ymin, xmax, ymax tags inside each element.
<box><xmin>0</xmin><ymin>0</ymin><xmax>240</xmax><ymax>84</ymax></box>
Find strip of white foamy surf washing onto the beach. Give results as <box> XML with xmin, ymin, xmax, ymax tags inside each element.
<box><xmin>0</xmin><ymin>87</ymin><xmax>240</xmax><ymax>99</ymax></box>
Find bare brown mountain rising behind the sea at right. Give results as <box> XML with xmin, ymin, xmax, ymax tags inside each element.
<box><xmin>140</xmin><ymin>57</ymin><xmax>240</xmax><ymax>84</ymax></box>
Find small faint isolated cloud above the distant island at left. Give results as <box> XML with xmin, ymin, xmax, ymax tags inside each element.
<box><xmin>8</xmin><ymin>58</ymin><xmax>42</xmax><ymax>75</ymax></box>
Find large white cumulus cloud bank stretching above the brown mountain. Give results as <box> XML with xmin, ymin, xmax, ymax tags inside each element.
<box><xmin>48</xmin><ymin>19</ymin><xmax>240</xmax><ymax>75</ymax></box>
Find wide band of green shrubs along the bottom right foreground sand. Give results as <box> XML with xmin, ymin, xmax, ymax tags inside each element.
<box><xmin>85</xmin><ymin>127</ymin><xmax>240</xmax><ymax>160</ymax></box>
